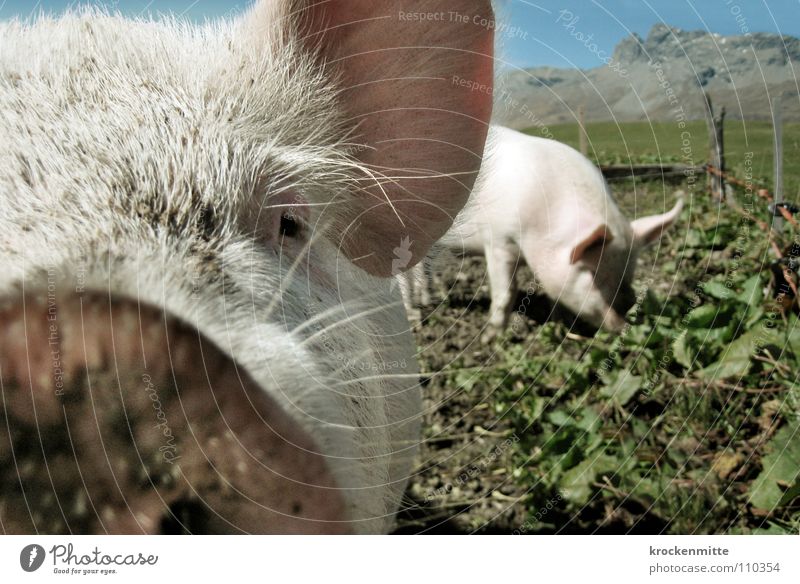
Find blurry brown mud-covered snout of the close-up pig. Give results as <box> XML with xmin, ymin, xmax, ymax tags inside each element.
<box><xmin>0</xmin><ymin>291</ymin><xmax>349</xmax><ymax>533</ymax></box>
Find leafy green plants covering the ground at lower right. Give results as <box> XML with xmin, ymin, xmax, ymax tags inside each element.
<box><xmin>452</xmin><ymin>181</ymin><xmax>800</xmax><ymax>533</ymax></box>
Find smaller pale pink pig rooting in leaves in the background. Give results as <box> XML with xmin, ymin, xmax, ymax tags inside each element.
<box><xmin>401</xmin><ymin>126</ymin><xmax>683</xmax><ymax>339</ymax></box>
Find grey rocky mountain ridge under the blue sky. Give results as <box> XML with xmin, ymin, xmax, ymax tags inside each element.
<box><xmin>495</xmin><ymin>24</ymin><xmax>800</xmax><ymax>130</ymax></box>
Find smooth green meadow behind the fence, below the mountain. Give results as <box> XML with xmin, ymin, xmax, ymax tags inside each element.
<box><xmin>529</xmin><ymin>120</ymin><xmax>800</xmax><ymax>200</ymax></box>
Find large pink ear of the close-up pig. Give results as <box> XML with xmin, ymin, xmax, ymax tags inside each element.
<box><xmin>252</xmin><ymin>0</ymin><xmax>495</xmax><ymax>276</ymax></box>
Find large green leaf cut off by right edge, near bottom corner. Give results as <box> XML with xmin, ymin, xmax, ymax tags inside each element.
<box><xmin>748</xmin><ymin>421</ymin><xmax>800</xmax><ymax>511</ymax></box>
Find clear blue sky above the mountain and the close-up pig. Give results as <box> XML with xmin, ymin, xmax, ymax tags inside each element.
<box><xmin>0</xmin><ymin>0</ymin><xmax>800</xmax><ymax>68</ymax></box>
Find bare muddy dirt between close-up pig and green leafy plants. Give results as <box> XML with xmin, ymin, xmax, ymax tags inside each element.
<box><xmin>397</xmin><ymin>258</ymin><xmax>552</xmax><ymax>534</ymax></box>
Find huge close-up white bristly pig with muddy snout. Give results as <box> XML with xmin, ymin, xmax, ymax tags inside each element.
<box><xmin>0</xmin><ymin>0</ymin><xmax>493</xmax><ymax>534</ymax></box>
